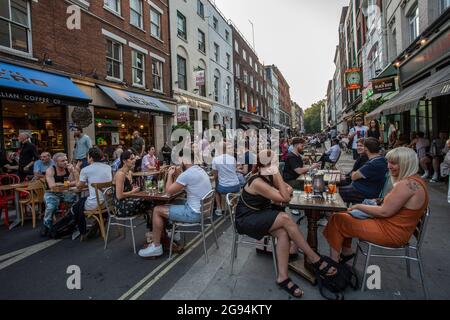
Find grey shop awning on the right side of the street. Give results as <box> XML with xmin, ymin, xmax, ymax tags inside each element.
<box><xmin>366</xmin><ymin>66</ymin><xmax>450</xmax><ymax>120</ymax></box>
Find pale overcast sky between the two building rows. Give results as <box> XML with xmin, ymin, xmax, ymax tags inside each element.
<box><xmin>213</xmin><ymin>0</ymin><xmax>349</xmax><ymax>109</ymax></box>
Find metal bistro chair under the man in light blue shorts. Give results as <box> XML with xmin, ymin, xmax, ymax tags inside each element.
<box><xmin>169</xmin><ymin>190</ymin><xmax>219</xmax><ymax>263</ymax></box>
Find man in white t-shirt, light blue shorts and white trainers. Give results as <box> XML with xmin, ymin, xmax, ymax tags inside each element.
<box><xmin>139</xmin><ymin>152</ymin><xmax>212</xmax><ymax>258</ymax></box>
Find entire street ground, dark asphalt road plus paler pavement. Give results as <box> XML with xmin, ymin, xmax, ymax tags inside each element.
<box><xmin>0</xmin><ymin>145</ymin><xmax>450</xmax><ymax>300</ymax></box>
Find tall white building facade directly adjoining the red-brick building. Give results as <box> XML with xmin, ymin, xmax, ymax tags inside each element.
<box><xmin>169</xmin><ymin>0</ymin><xmax>214</xmax><ymax>130</ymax></box>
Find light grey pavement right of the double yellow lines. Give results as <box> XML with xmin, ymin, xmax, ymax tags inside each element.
<box><xmin>162</xmin><ymin>146</ymin><xmax>450</xmax><ymax>300</ymax></box>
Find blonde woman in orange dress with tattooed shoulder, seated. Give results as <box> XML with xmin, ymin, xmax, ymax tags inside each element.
<box><xmin>323</xmin><ymin>147</ymin><xmax>428</xmax><ymax>263</ymax></box>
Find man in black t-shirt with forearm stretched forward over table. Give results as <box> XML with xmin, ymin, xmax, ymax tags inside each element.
<box><xmin>283</xmin><ymin>138</ymin><xmax>320</xmax><ymax>189</ymax></box>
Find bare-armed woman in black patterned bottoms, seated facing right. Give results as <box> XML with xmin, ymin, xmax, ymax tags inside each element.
<box><xmin>114</xmin><ymin>150</ymin><xmax>151</xmax><ymax>217</ymax></box>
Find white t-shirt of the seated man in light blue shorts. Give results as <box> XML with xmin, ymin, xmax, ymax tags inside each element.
<box><xmin>176</xmin><ymin>166</ymin><xmax>212</xmax><ymax>213</ymax></box>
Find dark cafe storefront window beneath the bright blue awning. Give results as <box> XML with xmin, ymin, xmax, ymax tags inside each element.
<box><xmin>2</xmin><ymin>100</ymin><xmax>67</xmax><ymax>154</ymax></box>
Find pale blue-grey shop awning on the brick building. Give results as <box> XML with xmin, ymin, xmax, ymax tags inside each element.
<box><xmin>98</xmin><ymin>85</ymin><xmax>173</xmax><ymax>115</ymax></box>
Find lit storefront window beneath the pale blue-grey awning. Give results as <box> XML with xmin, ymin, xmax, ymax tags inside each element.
<box><xmin>95</xmin><ymin>108</ymin><xmax>154</xmax><ymax>157</ymax></box>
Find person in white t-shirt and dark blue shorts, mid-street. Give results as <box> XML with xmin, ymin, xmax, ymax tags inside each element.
<box><xmin>211</xmin><ymin>144</ymin><xmax>241</xmax><ymax>216</ymax></box>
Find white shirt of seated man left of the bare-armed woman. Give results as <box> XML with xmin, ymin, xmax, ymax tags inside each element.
<box><xmin>80</xmin><ymin>162</ymin><xmax>112</xmax><ymax>210</ymax></box>
